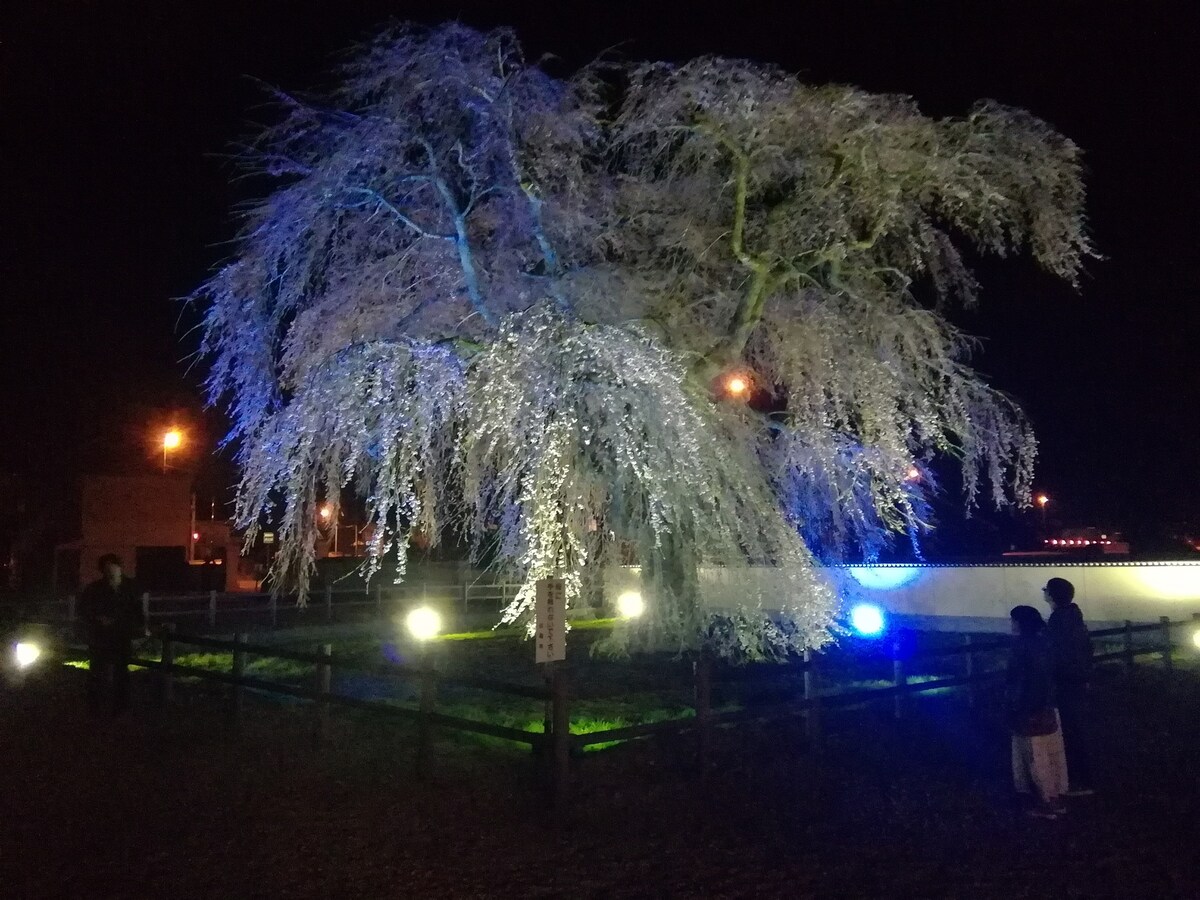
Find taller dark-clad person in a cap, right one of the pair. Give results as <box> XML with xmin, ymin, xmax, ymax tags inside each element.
<box><xmin>1042</xmin><ymin>578</ymin><xmax>1093</xmax><ymax>796</ymax></box>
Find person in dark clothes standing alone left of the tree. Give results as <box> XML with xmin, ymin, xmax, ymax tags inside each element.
<box><xmin>79</xmin><ymin>553</ymin><xmax>146</xmax><ymax>716</ymax></box>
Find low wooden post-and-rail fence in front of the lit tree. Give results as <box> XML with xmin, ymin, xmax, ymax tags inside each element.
<box><xmin>126</xmin><ymin>614</ymin><xmax>1200</xmax><ymax>796</ymax></box>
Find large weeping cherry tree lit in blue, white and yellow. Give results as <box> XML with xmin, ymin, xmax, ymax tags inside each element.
<box><xmin>198</xmin><ymin>25</ymin><xmax>1090</xmax><ymax>659</ymax></box>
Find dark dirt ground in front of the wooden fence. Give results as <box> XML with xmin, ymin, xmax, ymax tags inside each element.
<box><xmin>0</xmin><ymin>665</ymin><xmax>1200</xmax><ymax>899</ymax></box>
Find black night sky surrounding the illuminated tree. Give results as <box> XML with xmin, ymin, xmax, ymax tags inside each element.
<box><xmin>0</xmin><ymin>0</ymin><xmax>1200</xmax><ymax>549</ymax></box>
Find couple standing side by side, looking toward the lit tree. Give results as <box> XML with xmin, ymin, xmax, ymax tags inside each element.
<box><xmin>1008</xmin><ymin>578</ymin><xmax>1092</xmax><ymax>818</ymax></box>
